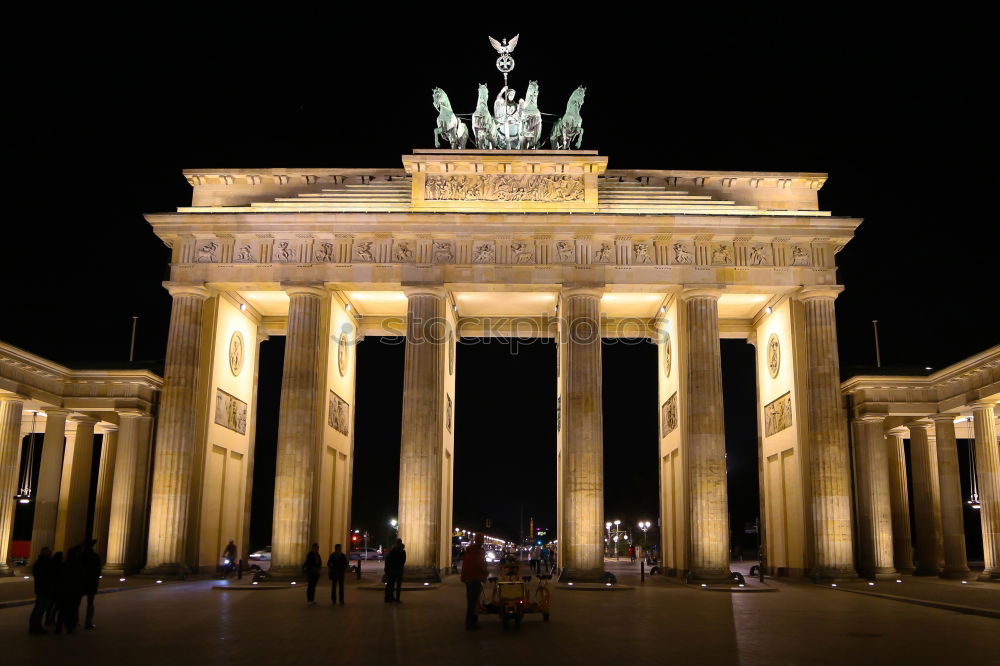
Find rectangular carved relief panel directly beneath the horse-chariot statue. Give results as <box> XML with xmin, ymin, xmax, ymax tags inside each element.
<box><xmin>424</xmin><ymin>174</ymin><xmax>584</xmax><ymax>201</ymax></box>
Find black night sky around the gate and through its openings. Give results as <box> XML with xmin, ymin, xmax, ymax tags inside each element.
<box><xmin>0</xmin><ymin>10</ymin><xmax>1000</xmax><ymax>547</ymax></box>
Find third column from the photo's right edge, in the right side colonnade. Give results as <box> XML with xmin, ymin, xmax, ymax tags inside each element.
<box><xmin>909</xmin><ymin>422</ymin><xmax>943</xmax><ymax>576</ymax></box>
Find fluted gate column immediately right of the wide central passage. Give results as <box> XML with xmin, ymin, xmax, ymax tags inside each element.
<box><xmin>559</xmin><ymin>288</ymin><xmax>604</xmax><ymax>581</ymax></box>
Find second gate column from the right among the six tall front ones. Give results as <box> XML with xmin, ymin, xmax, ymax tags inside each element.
<box><xmin>680</xmin><ymin>289</ymin><xmax>730</xmax><ymax>582</ymax></box>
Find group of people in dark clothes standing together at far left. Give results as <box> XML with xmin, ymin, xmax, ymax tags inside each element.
<box><xmin>28</xmin><ymin>539</ymin><xmax>101</xmax><ymax>634</ymax></box>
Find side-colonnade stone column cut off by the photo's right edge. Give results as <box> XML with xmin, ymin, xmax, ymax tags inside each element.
<box><xmin>972</xmin><ymin>401</ymin><xmax>1000</xmax><ymax>581</ymax></box>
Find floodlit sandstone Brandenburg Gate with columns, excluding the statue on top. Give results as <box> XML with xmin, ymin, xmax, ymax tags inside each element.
<box><xmin>139</xmin><ymin>149</ymin><xmax>860</xmax><ymax>581</ymax></box>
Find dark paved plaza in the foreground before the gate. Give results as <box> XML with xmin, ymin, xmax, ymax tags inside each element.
<box><xmin>0</xmin><ymin>562</ymin><xmax>1000</xmax><ymax>666</ymax></box>
